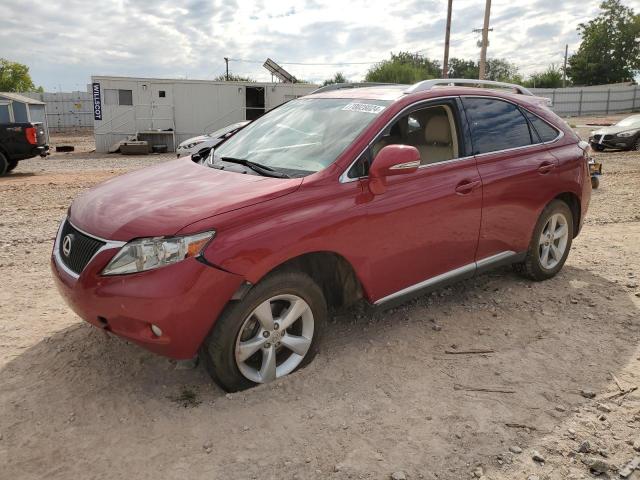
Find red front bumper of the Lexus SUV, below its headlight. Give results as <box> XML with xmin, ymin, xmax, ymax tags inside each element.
<box><xmin>51</xmin><ymin>231</ymin><xmax>243</xmax><ymax>360</ymax></box>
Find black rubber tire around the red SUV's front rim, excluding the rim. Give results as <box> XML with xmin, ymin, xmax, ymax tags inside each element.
<box><xmin>199</xmin><ymin>272</ymin><xmax>327</xmax><ymax>392</ymax></box>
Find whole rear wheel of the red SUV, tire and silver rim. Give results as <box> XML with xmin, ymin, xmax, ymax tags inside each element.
<box><xmin>516</xmin><ymin>200</ymin><xmax>573</xmax><ymax>280</ymax></box>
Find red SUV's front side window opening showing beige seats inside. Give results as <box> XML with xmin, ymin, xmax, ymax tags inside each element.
<box><xmin>372</xmin><ymin>105</ymin><xmax>458</xmax><ymax>165</ymax></box>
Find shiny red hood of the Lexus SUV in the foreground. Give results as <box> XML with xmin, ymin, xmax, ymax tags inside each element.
<box><xmin>70</xmin><ymin>158</ymin><xmax>302</xmax><ymax>242</ymax></box>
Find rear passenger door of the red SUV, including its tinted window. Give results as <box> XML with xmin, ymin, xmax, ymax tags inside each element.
<box><xmin>462</xmin><ymin>97</ymin><xmax>558</xmax><ymax>261</ymax></box>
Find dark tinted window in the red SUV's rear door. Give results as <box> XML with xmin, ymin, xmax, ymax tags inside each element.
<box><xmin>462</xmin><ymin>98</ymin><xmax>533</xmax><ymax>154</ymax></box>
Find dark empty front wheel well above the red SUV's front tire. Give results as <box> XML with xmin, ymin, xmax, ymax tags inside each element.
<box><xmin>249</xmin><ymin>251</ymin><xmax>365</xmax><ymax>311</ymax></box>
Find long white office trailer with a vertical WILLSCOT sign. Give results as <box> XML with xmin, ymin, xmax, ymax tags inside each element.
<box><xmin>90</xmin><ymin>76</ymin><xmax>318</xmax><ymax>152</ymax></box>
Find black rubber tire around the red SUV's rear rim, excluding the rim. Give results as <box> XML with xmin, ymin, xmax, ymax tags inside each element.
<box><xmin>514</xmin><ymin>200</ymin><xmax>573</xmax><ymax>281</ymax></box>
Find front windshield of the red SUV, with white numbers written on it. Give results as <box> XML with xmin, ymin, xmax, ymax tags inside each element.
<box><xmin>215</xmin><ymin>98</ymin><xmax>390</xmax><ymax>174</ymax></box>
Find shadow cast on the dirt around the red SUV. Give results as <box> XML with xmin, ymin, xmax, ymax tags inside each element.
<box><xmin>0</xmin><ymin>266</ymin><xmax>640</xmax><ymax>478</ymax></box>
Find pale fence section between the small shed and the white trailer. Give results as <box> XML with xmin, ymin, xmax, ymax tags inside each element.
<box><xmin>22</xmin><ymin>92</ymin><xmax>93</xmax><ymax>132</ymax></box>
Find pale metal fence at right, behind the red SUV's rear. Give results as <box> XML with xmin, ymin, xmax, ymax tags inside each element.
<box><xmin>530</xmin><ymin>84</ymin><xmax>640</xmax><ymax>117</ymax></box>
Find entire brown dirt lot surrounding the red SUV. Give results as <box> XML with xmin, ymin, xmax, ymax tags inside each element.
<box><xmin>0</xmin><ymin>119</ymin><xmax>640</xmax><ymax>480</ymax></box>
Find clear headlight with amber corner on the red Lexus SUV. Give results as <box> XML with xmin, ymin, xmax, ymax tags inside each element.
<box><xmin>102</xmin><ymin>231</ymin><xmax>216</xmax><ymax>275</ymax></box>
